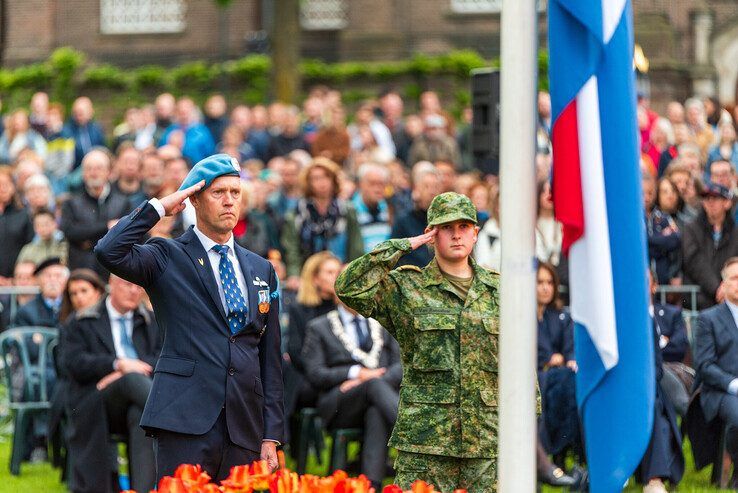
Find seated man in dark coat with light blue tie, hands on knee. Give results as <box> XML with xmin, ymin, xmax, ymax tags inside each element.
<box><xmin>62</xmin><ymin>276</ymin><xmax>161</xmax><ymax>492</ymax></box>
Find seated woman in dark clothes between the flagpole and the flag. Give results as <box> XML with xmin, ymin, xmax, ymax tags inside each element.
<box><xmin>536</xmin><ymin>262</ymin><xmax>584</xmax><ymax>472</ymax></box>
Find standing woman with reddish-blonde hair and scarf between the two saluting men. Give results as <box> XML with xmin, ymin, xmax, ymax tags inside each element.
<box><xmin>282</xmin><ymin>157</ymin><xmax>364</xmax><ymax>289</ymax></box>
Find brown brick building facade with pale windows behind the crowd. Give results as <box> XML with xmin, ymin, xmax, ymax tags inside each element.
<box><xmin>0</xmin><ymin>0</ymin><xmax>738</xmax><ymax>104</ymax></box>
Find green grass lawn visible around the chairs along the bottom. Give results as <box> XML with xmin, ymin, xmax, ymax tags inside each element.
<box><xmin>0</xmin><ymin>435</ymin><xmax>731</xmax><ymax>493</ymax></box>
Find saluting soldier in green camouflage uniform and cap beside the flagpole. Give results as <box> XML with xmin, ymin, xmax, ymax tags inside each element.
<box><xmin>336</xmin><ymin>192</ymin><xmax>499</xmax><ymax>493</ymax></box>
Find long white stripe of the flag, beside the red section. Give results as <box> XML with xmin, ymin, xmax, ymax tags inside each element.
<box><xmin>569</xmin><ymin>76</ymin><xmax>618</xmax><ymax>370</ymax></box>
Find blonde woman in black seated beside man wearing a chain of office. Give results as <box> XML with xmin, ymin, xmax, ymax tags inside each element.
<box><xmin>283</xmin><ymin>251</ymin><xmax>341</xmax><ymax>446</ymax></box>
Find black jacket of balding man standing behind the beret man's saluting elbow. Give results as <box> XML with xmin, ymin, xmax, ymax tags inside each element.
<box><xmin>61</xmin><ymin>187</ymin><xmax>131</xmax><ymax>278</ymax></box>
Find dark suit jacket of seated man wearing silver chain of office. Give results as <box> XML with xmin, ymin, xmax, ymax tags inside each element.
<box><xmin>302</xmin><ymin>312</ymin><xmax>402</xmax><ymax>425</ymax></box>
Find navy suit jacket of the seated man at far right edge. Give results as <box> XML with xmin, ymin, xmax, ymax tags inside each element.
<box><xmin>694</xmin><ymin>302</ymin><xmax>738</xmax><ymax>422</ymax></box>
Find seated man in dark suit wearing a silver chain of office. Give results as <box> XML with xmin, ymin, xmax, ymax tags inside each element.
<box><xmin>302</xmin><ymin>304</ymin><xmax>402</xmax><ymax>491</ymax></box>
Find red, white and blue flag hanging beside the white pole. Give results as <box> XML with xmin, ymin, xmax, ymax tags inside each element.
<box><xmin>548</xmin><ymin>0</ymin><xmax>655</xmax><ymax>493</ymax></box>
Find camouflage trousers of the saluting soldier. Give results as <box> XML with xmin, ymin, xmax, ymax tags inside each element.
<box><xmin>395</xmin><ymin>450</ymin><xmax>497</xmax><ymax>493</ymax></box>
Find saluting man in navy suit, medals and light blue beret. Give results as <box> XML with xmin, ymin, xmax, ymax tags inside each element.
<box><xmin>95</xmin><ymin>154</ymin><xmax>284</xmax><ymax>480</ymax></box>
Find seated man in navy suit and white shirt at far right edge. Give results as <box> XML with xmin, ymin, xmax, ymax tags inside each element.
<box><xmin>694</xmin><ymin>257</ymin><xmax>738</xmax><ymax>488</ymax></box>
